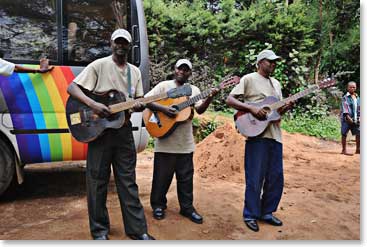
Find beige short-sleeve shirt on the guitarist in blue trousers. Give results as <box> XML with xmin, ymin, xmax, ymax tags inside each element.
<box><xmin>230</xmin><ymin>72</ymin><xmax>282</xmax><ymax>143</ymax></box>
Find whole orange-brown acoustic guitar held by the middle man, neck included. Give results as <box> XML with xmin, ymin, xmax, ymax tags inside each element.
<box><xmin>143</xmin><ymin>76</ymin><xmax>240</xmax><ymax>138</ymax></box>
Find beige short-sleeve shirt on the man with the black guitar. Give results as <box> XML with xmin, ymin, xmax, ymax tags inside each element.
<box><xmin>74</xmin><ymin>56</ymin><xmax>144</xmax><ymax>98</ymax></box>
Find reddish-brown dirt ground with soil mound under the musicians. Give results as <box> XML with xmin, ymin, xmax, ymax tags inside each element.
<box><xmin>0</xmin><ymin>118</ymin><xmax>360</xmax><ymax>240</ymax></box>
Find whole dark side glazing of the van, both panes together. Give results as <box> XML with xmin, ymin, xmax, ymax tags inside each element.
<box><xmin>0</xmin><ymin>0</ymin><xmax>130</xmax><ymax>66</ymax></box>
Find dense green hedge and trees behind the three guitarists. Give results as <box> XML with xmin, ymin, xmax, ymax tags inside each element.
<box><xmin>144</xmin><ymin>0</ymin><xmax>360</xmax><ymax>117</ymax></box>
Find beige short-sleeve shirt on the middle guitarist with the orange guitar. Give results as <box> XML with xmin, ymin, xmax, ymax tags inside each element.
<box><xmin>145</xmin><ymin>80</ymin><xmax>202</xmax><ymax>153</ymax></box>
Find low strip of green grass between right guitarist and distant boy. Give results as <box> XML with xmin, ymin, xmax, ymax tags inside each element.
<box><xmin>282</xmin><ymin>115</ymin><xmax>341</xmax><ymax>141</ymax></box>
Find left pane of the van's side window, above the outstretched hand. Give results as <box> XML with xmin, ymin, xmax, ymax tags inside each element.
<box><xmin>0</xmin><ymin>0</ymin><xmax>57</xmax><ymax>60</ymax></box>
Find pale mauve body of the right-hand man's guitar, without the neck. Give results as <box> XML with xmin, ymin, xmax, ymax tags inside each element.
<box><xmin>234</xmin><ymin>96</ymin><xmax>280</xmax><ymax>137</ymax></box>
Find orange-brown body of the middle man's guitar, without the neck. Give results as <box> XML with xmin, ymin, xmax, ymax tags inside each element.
<box><xmin>143</xmin><ymin>97</ymin><xmax>191</xmax><ymax>138</ymax></box>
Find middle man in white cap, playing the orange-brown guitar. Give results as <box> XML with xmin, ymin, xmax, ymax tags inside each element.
<box><xmin>145</xmin><ymin>59</ymin><xmax>218</xmax><ymax>224</ymax></box>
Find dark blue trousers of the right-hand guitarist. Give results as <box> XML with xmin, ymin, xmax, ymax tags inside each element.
<box><xmin>243</xmin><ymin>138</ymin><xmax>284</xmax><ymax>220</ymax></box>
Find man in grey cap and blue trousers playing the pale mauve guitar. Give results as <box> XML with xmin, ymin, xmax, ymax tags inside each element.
<box><xmin>227</xmin><ymin>50</ymin><xmax>293</xmax><ymax>232</ymax></box>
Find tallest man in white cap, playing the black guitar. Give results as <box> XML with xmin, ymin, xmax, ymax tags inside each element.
<box><xmin>68</xmin><ymin>29</ymin><xmax>154</xmax><ymax>240</ymax></box>
